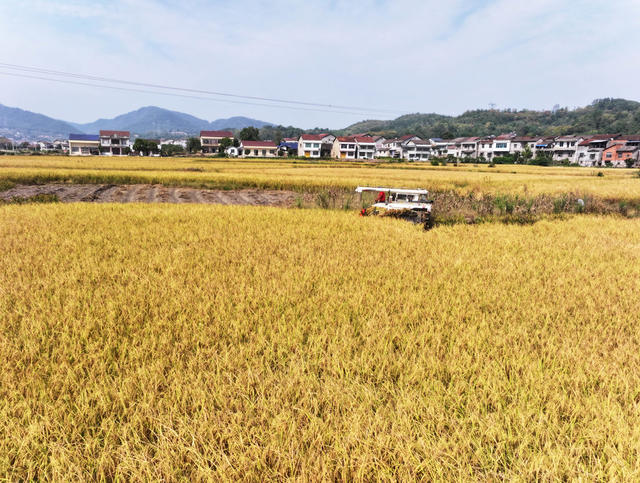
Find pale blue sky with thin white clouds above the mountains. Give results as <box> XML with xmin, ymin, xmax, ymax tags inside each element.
<box><xmin>0</xmin><ymin>0</ymin><xmax>640</xmax><ymax>129</ymax></box>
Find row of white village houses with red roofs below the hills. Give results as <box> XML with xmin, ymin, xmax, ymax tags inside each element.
<box><xmin>0</xmin><ymin>130</ymin><xmax>640</xmax><ymax>168</ymax></box>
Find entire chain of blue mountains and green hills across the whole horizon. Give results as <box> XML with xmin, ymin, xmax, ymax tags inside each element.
<box><xmin>0</xmin><ymin>98</ymin><xmax>640</xmax><ymax>140</ymax></box>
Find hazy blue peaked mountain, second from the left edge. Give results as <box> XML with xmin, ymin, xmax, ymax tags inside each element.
<box><xmin>74</xmin><ymin>106</ymin><xmax>270</xmax><ymax>136</ymax></box>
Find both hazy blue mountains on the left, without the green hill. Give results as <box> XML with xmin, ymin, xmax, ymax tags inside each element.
<box><xmin>0</xmin><ymin>104</ymin><xmax>271</xmax><ymax>140</ymax></box>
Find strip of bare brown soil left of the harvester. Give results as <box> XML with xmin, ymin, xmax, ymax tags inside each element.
<box><xmin>0</xmin><ymin>183</ymin><xmax>297</xmax><ymax>206</ymax></box>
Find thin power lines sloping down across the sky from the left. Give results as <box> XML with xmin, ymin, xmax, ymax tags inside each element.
<box><xmin>0</xmin><ymin>62</ymin><xmax>399</xmax><ymax>114</ymax></box>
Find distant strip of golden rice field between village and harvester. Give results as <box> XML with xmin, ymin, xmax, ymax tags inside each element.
<box><xmin>0</xmin><ymin>156</ymin><xmax>640</xmax><ymax>200</ymax></box>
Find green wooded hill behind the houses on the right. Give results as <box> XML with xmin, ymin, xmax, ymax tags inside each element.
<box><xmin>340</xmin><ymin>99</ymin><xmax>640</xmax><ymax>138</ymax></box>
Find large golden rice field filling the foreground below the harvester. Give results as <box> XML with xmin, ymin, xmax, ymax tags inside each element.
<box><xmin>0</xmin><ymin>202</ymin><xmax>640</xmax><ymax>480</ymax></box>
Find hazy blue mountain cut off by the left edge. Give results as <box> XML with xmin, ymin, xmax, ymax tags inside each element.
<box><xmin>0</xmin><ymin>104</ymin><xmax>80</xmax><ymax>140</ymax></box>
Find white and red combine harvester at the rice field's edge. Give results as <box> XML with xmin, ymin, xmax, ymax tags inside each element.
<box><xmin>356</xmin><ymin>186</ymin><xmax>433</xmax><ymax>230</ymax></box>
